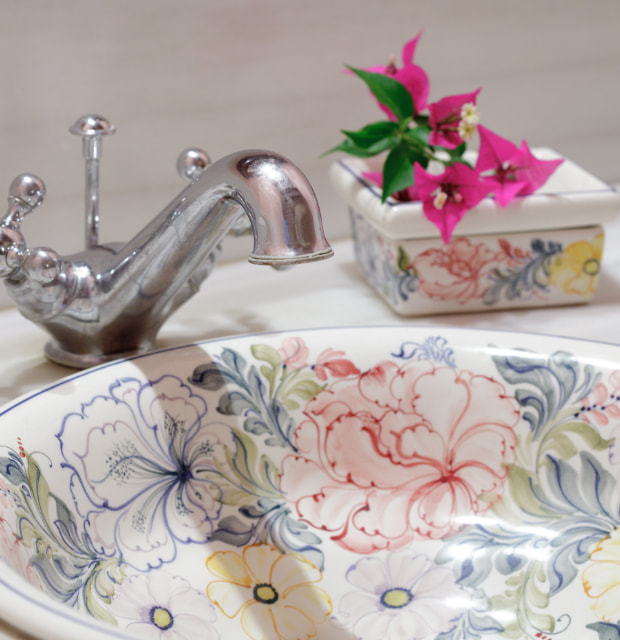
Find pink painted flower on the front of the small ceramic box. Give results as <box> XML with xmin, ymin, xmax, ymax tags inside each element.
<box><xmin>412</xmin><ymin>238</ymin><xmax>508</xmax><ymax>303</ymax></box>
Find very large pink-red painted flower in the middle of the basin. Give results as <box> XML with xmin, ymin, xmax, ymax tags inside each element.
<box><xmin>281</xmin><ymin>360</ymin><xmax>519</xmax><ymax>553</ymax></box>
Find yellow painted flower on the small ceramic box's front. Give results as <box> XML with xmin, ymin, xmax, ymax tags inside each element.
<box><xmin>549</xmin><ymin>233</ymin><xmax>604</xmax><ymax>296</ymax></box>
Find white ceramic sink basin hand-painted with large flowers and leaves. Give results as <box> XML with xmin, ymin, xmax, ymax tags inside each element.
<box><xmin>0</xmin><ymin>327</ymin><xmax>620</xmax><ymax>640</ymax></box>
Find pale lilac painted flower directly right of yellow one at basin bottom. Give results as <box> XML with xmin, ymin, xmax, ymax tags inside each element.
<box><xmin>335</xmin><ymin>552</ymin><xmax>471</xmax><ymax>640</ymax></box>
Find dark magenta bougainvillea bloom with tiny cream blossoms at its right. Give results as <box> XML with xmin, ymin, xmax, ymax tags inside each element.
<box><xmin>428</xmin><ymin>89</ymin><xmax>481</xmax><ymax>149</ymax></box>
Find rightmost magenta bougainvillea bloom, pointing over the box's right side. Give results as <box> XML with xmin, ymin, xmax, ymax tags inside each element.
<box><xmin>476</xmin><ymin>126</ymin><xmax>562</xmax><ymax>207</ymax></box>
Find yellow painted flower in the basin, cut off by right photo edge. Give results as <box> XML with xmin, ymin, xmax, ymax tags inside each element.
<box><xmin>581</xmin><ymin>529</ymin><xmax>620</xmax><ymax>622</ymax></box>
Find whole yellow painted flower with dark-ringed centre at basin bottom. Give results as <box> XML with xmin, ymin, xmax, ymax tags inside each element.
<box><xmin>206</xmin><ymin>544</ymin><xmax>332</xmax><ymax>640</ymax></box>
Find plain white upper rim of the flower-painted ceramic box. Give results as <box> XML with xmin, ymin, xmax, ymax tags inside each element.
<box><xmin>329</xmin><ymin>148</ymin><xmax>620</xmax><ymax>239</ymax></box>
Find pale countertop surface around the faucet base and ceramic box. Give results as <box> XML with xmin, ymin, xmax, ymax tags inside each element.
<box><xmin>0</xmin><ymin>221</ymin><xmax>620</xmax><ymax>640</ymax></box>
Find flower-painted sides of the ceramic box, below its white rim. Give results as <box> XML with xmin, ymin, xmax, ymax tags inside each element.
<box><xmin>351</xmin><ymin>212</ymin><xmax>604</xmax><ymax>314</ymax></box>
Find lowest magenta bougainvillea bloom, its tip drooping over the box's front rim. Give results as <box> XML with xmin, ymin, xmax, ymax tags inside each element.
<box><xmin>414</xmin><ymin>162</ymin><xmax>492</xmax><ymax>244</ymax></box>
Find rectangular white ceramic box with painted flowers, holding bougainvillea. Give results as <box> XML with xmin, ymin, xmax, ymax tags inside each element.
<box><xmin>330</xmin><ymin>149</ymin><xmax>620</xmax><ymax>315</ymax></box>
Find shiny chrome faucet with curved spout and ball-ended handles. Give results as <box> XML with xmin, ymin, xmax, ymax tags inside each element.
<box><xmin>0</xmin><ymin>115</ymin><xmax>333</xmax><ymax>368</ymax></box>
